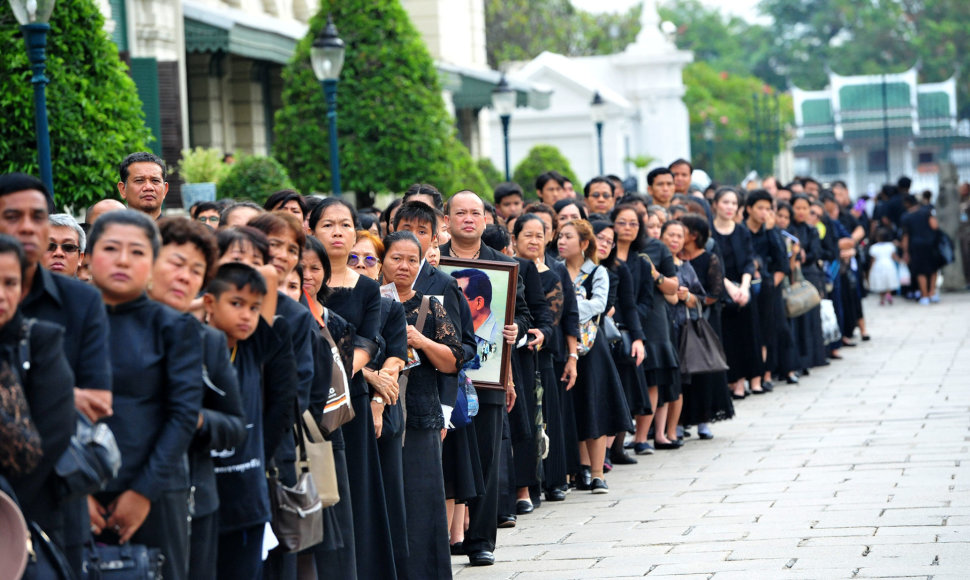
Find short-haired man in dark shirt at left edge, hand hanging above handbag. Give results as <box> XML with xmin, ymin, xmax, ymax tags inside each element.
<box><xmin>0</xmin><ymin>173</ymin><xmax>111</xmax><ymax>571</ymax></box>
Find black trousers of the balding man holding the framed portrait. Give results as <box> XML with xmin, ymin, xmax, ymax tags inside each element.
<box><xmin>463</xmin><ymin>402</ymin><xmax>505</xmax><ymax>554</ymax></box>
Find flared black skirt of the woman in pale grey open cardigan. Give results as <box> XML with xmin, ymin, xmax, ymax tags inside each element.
<box><xmin>572</xmin><ymin>332</ymin><xmax>633</xmax><ymax>441</ymax></box>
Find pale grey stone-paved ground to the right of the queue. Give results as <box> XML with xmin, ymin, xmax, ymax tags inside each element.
<box><xmin>452</xmin><ymin>294</ymin><xmax>970</xmax><ymax>580</ymax></box>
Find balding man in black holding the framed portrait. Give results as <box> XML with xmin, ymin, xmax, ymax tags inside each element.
<box><xmin>441</xmin><ymin>191</ymin><xmax>532</xmax><ymax>566</ymax></box>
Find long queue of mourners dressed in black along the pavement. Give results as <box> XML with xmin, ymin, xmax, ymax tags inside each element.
<box><xmin>0</xmin><ymin>153</ymin><xmax>888</xmax><ymax>579</ymax></box>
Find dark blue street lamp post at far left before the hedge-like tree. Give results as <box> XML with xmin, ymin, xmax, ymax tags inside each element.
<box><xmin>10</xmin><ymin>0</ymin><xmax>54</xmax><ymax>204</ymax></box>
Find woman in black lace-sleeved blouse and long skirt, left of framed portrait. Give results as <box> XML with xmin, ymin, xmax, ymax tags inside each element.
<box><xmin>383</xmin><ymin>231</ymin><xmax>463</xmax><ymax>578</ymax></box>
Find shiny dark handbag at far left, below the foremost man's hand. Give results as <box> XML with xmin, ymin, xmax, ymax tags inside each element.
<box><xmin>54</xmin><ymin>413</ymin><xmax>121</xmax><ymax>498</ymax></box>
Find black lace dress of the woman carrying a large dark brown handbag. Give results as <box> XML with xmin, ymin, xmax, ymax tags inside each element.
<box><xmin>680</xmin><ymin>252</ymin><xmax>734</xmax><ymax>425</ymax></box>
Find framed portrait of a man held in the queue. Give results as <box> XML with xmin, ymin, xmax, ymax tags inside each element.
<box><xmin>438</xmin><ymin>256</ymin><xmax>519</xmax><ymax>390</ymax></box>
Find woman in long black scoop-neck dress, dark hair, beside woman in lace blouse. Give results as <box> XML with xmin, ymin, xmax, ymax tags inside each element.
<box><xmin>310</xmin><ymin>198</ymin><xmax>397</xmax><ymax>578</ymax></box>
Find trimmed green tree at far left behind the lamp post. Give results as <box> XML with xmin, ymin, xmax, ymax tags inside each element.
<box><xmin>0</xmin><ymin>0</ymin><xmax>152</xmax><ymax>207</ymax></box>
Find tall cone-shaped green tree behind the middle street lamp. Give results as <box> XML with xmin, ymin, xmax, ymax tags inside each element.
<box><xmin>274</xmin><ymin>0</ymin><xmax>490</xmax><ymax>207</ymax></box>
